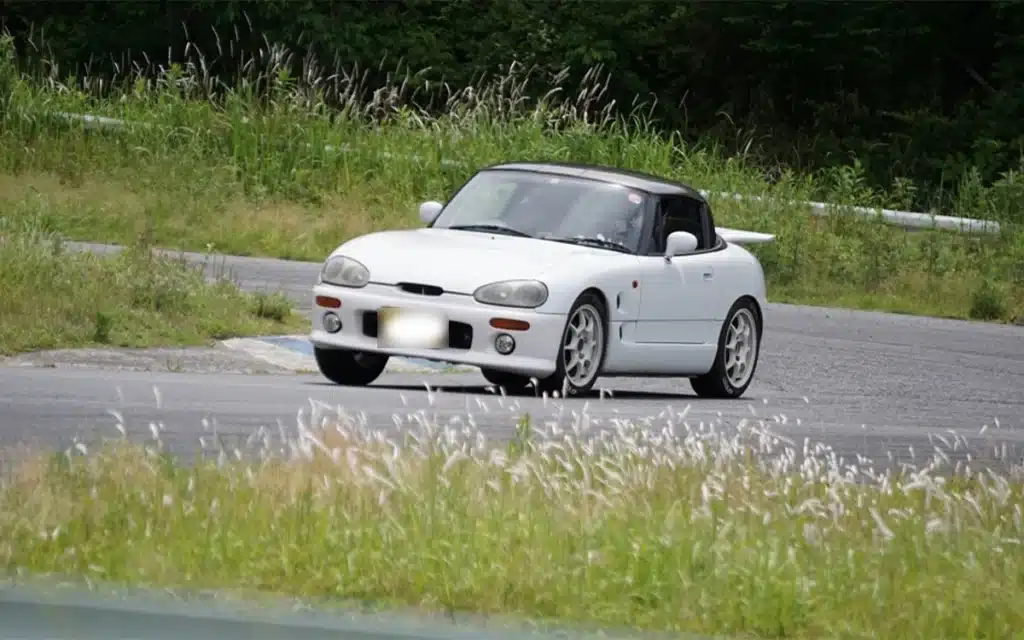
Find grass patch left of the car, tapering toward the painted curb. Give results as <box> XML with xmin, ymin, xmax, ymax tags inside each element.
<box><xmin>0</xmin><ymin>218</ymin><xmax>305</xmax><ymax>355</ymax></box>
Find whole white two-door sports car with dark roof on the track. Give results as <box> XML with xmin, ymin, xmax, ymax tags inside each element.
<box><xmin>310</xmin><ymin>162</ymin><xmax>774</xmax><ymax>397</ymax></box>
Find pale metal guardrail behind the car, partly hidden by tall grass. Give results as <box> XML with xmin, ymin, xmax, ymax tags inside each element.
<box><xmin>55</xmin><ymin>112</ymin><xmax>1000</xmax><ymax>233</ymax></box>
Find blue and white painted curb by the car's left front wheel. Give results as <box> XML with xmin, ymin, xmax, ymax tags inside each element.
<box><xmin>221</xmin><ymin>335</ymin><xmax>478</xmax><ymax>374</ymax></box>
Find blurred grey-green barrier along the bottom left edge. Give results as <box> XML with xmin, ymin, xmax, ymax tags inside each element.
<box><xmin>0</xmin><ymin>583</ymin><xmax>713</xmax><ymax>640</ymax></box>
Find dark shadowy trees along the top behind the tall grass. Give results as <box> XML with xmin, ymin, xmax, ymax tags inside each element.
<box><xmin>6</xmin><ymin>0</ymin><xmax>1024</xmax><ymax>219</ymax></box>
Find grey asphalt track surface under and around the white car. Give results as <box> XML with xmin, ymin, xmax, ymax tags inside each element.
<box><xmin>0</xmin><ymin>240</ymin><xmax>1024</xmax><ymax>468</ymax></box>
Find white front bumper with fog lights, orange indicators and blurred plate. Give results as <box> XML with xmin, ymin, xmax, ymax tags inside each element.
<box><xmin>309</xmin><ymin>283</ymin><xmax>565</xmax><ymax>378</ymax></box>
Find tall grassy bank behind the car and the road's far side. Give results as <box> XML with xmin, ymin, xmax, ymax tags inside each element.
<box><xmin>0</xmin><ymin>33</ymin><xmax>1024</xmax><ymax>322</ymax></box>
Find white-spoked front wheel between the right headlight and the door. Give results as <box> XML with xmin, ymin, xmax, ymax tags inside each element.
<box><xmin>539</xmin><ymin>292</ymin><xmax>606</xmax><ymax>397</ymax></box>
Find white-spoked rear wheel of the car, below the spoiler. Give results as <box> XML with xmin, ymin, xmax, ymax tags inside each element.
<box><xmin>690</xmin><ymin>300</ymin><xmax>761</xmax><ymax>398</ymax></box>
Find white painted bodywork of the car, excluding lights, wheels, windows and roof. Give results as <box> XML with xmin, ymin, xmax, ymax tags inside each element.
<box><xmin>310</xmin><ymin>224</ymin><xmax>766</xmax><ymax>378</ymax></box>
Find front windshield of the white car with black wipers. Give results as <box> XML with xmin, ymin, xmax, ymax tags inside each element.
<box><xmin>433</xmin><ymin>169</ymin><xmax>647</xmax><ymax>253</ymax></box>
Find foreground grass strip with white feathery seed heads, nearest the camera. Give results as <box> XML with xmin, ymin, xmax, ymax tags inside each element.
<box><xmin>0</xmin><ymin>397</ymin><xmax>1024</xmax><ymax>639</ymax></box>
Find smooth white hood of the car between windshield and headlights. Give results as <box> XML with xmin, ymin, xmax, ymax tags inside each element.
<box><xmin>333</xmin><ymin>228</ymin><xmax>607</xmax><ymax>294</ymax></box>
